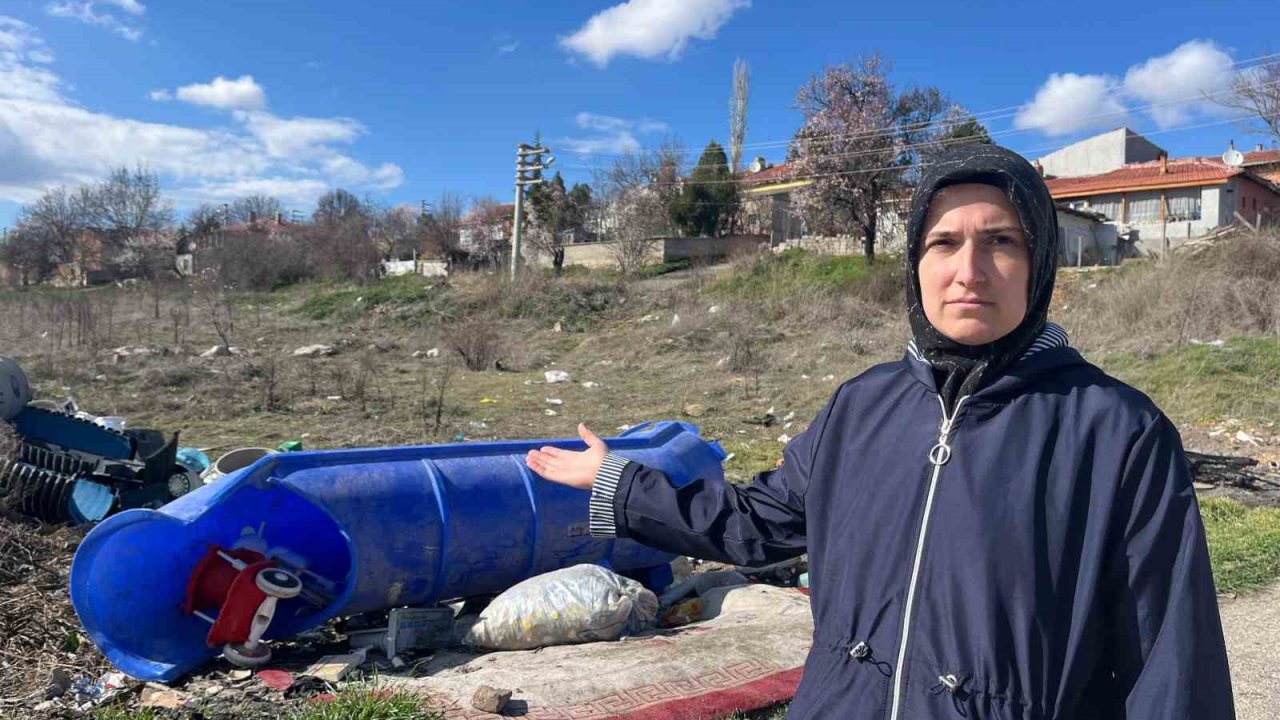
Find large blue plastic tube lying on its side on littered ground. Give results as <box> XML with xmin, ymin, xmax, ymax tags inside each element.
<box><xmin>70</xmin><ymin>421</ymin><xmax>724</xmax><ymax>682</ymax></box>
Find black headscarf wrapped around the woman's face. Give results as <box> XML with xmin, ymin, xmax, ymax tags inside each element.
<box><xmin>906</xmin><ymin>143</ymin><xmax>1059</xmax><ymax>411</ymax></box>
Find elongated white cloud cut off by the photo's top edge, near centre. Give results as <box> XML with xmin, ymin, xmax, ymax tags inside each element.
<box><xmin>559</xmin><ymin>0</ymin><xmax>751</xmax><ymax>68</ymax></box>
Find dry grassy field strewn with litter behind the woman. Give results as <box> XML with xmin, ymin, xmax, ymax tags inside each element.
<box><xmin>0</xmin><ymin>233</ymin><xmax>1280</xmax><ymax>720</ymax></box>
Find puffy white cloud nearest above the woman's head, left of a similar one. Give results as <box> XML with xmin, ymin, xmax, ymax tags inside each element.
<box><xmin>1014</xmin><ymin>73</ymin><xmax>1128</xmax><ymax>136</ymax></box>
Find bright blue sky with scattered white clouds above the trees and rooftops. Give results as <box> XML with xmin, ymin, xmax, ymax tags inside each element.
<box><xmin>0</xmin><ymin>0</ymin><xmax>1280</xmax><ymax>227</ymax></box>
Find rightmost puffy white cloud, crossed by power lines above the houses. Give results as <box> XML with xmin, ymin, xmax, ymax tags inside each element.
<box><xmin>1124</xmin><ymin>40</ymin><xmax>1234</xmax><ymax>128</ymax></box>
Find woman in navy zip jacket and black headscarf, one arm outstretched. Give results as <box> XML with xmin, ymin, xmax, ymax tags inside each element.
<box><xmin>526</xmin><ymin>145</ymin><xmax>1234</xmax><ymax>720</ymax></box>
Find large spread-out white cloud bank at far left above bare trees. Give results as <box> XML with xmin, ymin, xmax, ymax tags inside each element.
<box><xmin>0</xmin><ymin>17</ymin><xmax>404</xmax><ymax>206</ymax></box>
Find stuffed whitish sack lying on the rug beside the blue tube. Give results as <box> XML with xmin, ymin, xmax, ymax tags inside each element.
<box><xmin>463</xmin><ymin>565</ymin><xmax>658</xmax><ymax>650</ymax></box>
